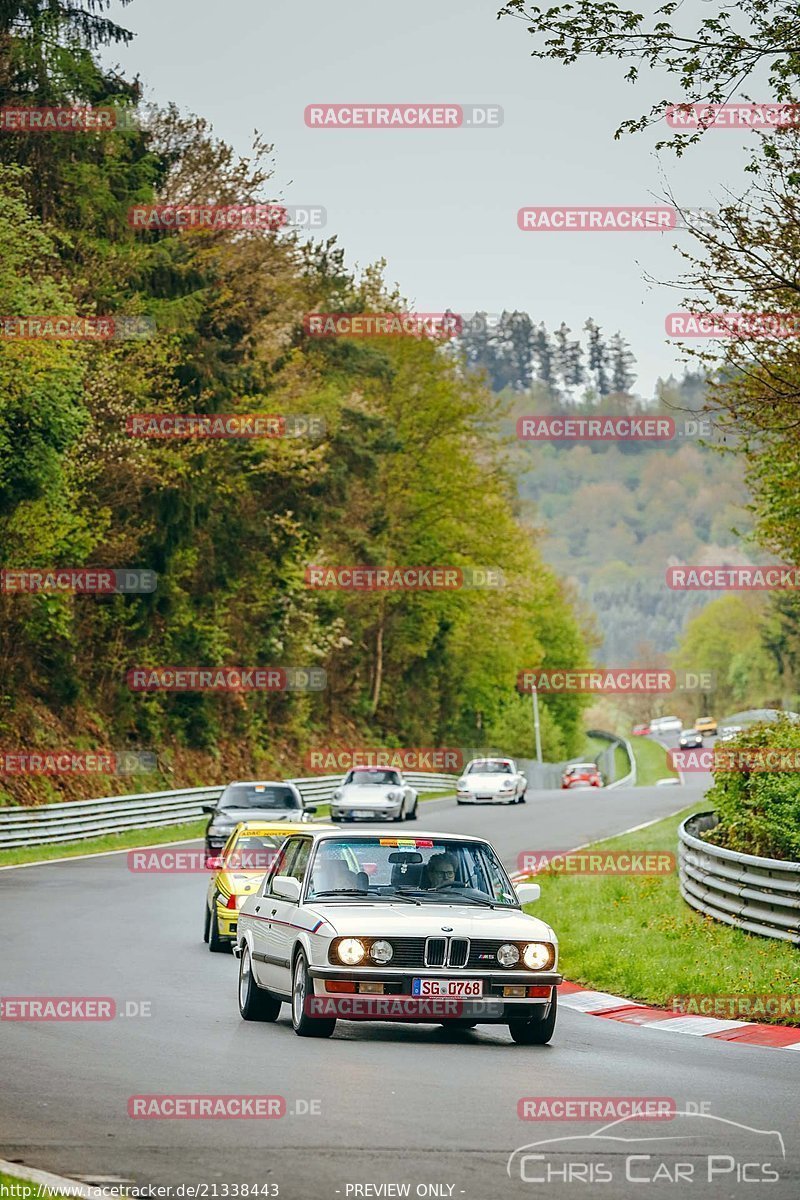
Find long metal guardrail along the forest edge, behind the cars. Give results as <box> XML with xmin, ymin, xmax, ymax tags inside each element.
<box><xmin>0</xmin><ymin>772</ymin><xmax>457</xmax><ymax>850</ymax></box>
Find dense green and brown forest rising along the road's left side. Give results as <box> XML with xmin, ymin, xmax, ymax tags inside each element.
<box><xmin>0</xmin><ymin>7</ymin><xmax>589</xmax><ymax>802</ymax></box>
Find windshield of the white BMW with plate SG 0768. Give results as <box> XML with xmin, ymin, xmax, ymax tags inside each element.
<box><xmin>307</xmin><ymin>838</ymin><xmax>517</xmax><ymax>906</ymax></box>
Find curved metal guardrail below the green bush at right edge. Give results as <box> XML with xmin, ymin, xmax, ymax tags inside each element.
<box><xmin>678</xmin><ymin>812</ymin><xmax>800</xmax><ymax>946</ymax></box>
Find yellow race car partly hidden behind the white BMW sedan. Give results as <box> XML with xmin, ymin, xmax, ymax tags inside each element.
<box><xmin>203</xmin><ymin>821</ymin><xmax>326</xmax><ymax>953</ymax></box>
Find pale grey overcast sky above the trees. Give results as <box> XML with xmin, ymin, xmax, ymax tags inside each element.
<box><xmin>104</xmin><ymin>0</ymin><xmax>753</xmax><ymax>395</ymax></box>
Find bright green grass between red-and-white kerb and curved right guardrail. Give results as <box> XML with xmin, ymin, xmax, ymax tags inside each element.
<box><xmin>528</xmin><ymin>804</ymin><xmax>800</xmax><ymax>1025</ymax></box>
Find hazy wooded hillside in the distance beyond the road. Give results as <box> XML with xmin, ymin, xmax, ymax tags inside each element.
<box><xmin>505</xmin><ymin>376</ymin><xmax>757</xmax><ymax>665</ymax></box>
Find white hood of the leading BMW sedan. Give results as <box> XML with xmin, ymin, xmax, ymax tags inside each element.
<box><xmin>307</xmin><ymin>900</ymin><xmax>555</xmax><ymax>942</ymax></box>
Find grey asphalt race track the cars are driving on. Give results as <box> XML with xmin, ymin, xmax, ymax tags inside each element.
<box><xmin>0</xmin><ymin>780</ymin><xmax>800</xmax><ymax>1200</ymax></box>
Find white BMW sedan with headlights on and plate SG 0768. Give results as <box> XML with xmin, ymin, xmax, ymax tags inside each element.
<box><xmin>235</xmin><ymin>826</ymin><xmax>561</xmax><ymax>1045</ymax></box>
